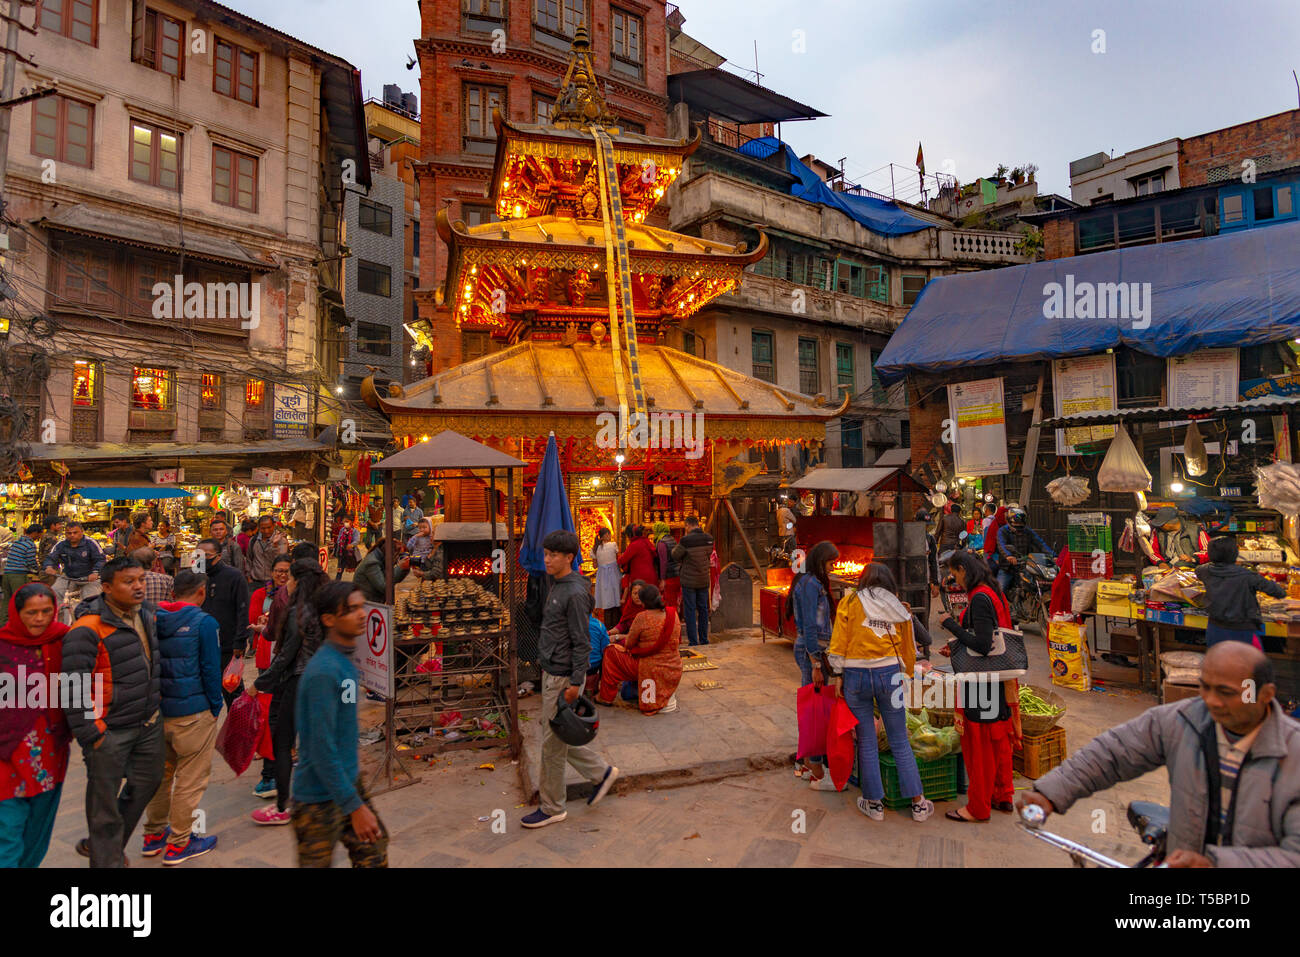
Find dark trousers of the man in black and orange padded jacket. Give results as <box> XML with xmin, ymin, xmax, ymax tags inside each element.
<box><xmin>82</xmin><ymin>715</ymin><xmax>164</xmax><ymax>867</ymax></box>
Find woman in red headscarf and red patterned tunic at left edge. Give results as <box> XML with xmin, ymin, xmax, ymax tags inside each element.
<box><xmin>0</xmin><ymin>581</ymin><xmax>70</xmax><ymax>867</ymax></box>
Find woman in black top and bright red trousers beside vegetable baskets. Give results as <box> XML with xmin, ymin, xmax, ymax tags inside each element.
<box><xmin>941</xmin><ymin>550</ymin><xmax>1021</xmax><ymax>823</ymax></box>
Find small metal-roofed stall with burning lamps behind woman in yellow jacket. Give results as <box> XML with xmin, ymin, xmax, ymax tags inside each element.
<box><xmin>758</xmin><ymin>468</ymin><xmax>928</xmax><ymax>641</ymax></box>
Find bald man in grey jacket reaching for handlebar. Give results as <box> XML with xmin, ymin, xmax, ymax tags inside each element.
<box><xmin>1017</xmin><ymin>641</ymin><xmax>1300</xmax><ymax>867</ymax></box>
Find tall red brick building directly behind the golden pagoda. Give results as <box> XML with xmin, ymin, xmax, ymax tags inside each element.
<box><xmin>416</xmin><ymin>0</ymin><xmax>668</xmax><ymax>371</ymax></box>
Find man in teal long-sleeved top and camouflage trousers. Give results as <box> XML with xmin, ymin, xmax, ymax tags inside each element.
<box><xmin>293</xmin><ymin>581</ymin><xmax>389</xmax><ymax>867</ymax></box>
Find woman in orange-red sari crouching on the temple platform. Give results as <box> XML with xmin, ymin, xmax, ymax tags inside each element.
<box><xmin>595</xmin><ymin>585</ymin><xmax>681</xmax><ymax>714</ymax></box>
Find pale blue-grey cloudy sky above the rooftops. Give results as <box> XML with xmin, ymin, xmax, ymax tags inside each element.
<box><xmin>241</xmin><ymin>0</ymin><xmax>1300</xmax><ymax>199</ymax></box>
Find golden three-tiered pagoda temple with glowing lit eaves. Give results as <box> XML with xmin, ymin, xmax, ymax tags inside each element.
<box><xmin>363</xmin><ymin>27</ymin><xmax>848</xmax><ymax>555</ymax></box>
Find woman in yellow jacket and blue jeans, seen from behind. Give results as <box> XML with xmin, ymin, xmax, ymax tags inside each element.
<box><xmin>827</xmin><ymin>563</ymin><xmax>935</xmax><ymax>820</ymax></box>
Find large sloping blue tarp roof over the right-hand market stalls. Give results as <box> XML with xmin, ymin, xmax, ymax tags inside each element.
<box><xmin>876</xmin><ymin>222</ymin><xmax>1300</xmax><ymax>382</ymax></box>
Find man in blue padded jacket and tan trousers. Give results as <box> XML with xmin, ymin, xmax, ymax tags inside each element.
<box><xmin>143</xmin><ymin>568</ymin><xmax>224</xmax><ymax>865</ymax></box>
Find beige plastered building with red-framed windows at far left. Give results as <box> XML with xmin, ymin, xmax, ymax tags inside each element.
<box><xmin>5</xmin><ymin>0</ymin><xmax>371</xmax><ymax>494</ymax></box>
